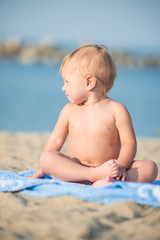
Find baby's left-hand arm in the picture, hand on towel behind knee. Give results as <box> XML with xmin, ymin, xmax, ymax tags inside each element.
<box><xmin>32</xmin><ymin>104</ymin><xmax>70</xmax><ymax>178</ymax></box>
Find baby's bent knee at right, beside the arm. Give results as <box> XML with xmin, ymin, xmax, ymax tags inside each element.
<box><xmin>127</xmin><ymin>160</ymin><xmax>158</xmax><ymax>183</ymax></box>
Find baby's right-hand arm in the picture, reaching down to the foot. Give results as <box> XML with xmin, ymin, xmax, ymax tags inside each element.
<box><xmin>115</xmin><ymin>104</ymin><xmax>137</xmax><ymax>180</ymax></box>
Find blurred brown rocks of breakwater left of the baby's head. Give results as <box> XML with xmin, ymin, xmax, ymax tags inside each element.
<box><xmin>0</xmin><ymin>39</ymin><xmax>67</xmax><ymax>64</ymax></box>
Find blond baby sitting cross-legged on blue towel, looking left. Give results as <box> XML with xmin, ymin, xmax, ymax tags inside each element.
<box><xmin>32</xmin><ymin>45</ymin><xmax>158</xmax><ymax>187</ymax></box>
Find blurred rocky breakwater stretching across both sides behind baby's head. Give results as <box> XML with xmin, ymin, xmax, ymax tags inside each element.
<box><xmin>0</xmin><ymin>38</ymin><xmax>160</xmax><ymax>69</ymax></box>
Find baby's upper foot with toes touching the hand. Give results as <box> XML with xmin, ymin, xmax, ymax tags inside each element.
<box><xmin>92</xmin><ymin>159</ymin><xmax>118</xmax><ymax>182</ymax></box>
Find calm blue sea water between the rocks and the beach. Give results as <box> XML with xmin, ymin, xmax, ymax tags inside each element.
<box><xmin>0</xmin><ymin>61</ymin><xmax>160</xmax><ymax>137</ymax></box>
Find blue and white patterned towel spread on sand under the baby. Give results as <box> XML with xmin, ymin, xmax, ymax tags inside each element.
<box><xmin>0</xmin><ymin>170</ymin><xmax>160</xmax><ymax>208</ymax></box>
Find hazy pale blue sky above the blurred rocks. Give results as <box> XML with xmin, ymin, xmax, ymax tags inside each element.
<box><xmin>0</xmin><ymin>0</ymin><xmax>160</xmax><ymax>49</ymax></box>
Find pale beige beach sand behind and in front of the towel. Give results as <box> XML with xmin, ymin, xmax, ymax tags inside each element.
<box><xmin>0</xmin><ymin>132</ymin><xmax>160</xmax><ymax>240</ymax></box>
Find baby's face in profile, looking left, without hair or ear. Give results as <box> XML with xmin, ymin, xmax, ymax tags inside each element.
<box><xmin>61</xmin><ymin>64</ymin><xmax>88</xmax><ymax>104</ymax></box>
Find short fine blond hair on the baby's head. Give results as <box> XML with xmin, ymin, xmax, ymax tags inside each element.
<box><xmin>60</xmin><ymin>45</ymin><xmax>116</xmax><ymax>93</ymax></box>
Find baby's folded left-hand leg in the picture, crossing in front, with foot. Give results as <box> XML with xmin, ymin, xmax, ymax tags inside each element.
<box><xmin>33</xmin><ymin>151</ymin><xmax>118</xmax><ymax>182</ymax></box>
